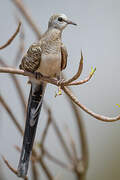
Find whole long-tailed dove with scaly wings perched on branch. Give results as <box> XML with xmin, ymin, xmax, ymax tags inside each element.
<box><xmin>17</xmin><ymin>14</ymin><xmax>77</xmax><ymax>178</ymax></box>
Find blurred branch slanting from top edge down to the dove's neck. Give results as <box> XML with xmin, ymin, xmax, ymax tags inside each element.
<box><xmin>12</xmin><ymin>0</ymin><xmax>41</xmax><ymax>39</ymax></box>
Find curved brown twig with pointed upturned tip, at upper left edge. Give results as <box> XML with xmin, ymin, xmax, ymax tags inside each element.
<box><xmin>0</xmin><ymin>22</ymin><xmax>21</xmax><ymax>49</ymax></box>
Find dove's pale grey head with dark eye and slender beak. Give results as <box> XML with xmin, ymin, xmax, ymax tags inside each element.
<box><xmin>48</xmin><ymin>14</ymin><xmax>77</xmax><ymax>31</ymax></box>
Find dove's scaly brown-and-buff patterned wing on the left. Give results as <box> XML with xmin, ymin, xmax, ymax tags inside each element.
<box><xmin>19</xmin><ymin>43</ymin><xmax>42</xmax><ymax>72</ymax></box>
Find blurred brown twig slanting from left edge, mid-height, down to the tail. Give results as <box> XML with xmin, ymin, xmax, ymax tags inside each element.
<box><xmin>0</xmin><ymin>95</ymin><xmax>23</xmax><ymax>135</ymax></box>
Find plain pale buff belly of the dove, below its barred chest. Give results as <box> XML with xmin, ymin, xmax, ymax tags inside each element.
<box><xmin>37</xmin><ymin>53</ymin><xmax>61</xmax><ymax>77</ymax></box>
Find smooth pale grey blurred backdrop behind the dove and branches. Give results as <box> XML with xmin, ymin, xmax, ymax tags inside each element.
<box><xmin>0</xmin><ymin>0</ymin><xmax>120</xmax><ymax>180</ymax></box>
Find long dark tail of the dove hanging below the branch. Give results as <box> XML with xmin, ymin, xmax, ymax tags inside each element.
<box><xmin>18</xmin><ymin>82</ymin><xmax>45</xmax><ymax>177</ymax></box>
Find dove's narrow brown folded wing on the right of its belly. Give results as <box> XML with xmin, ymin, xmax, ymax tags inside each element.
<box><xmin>61</xmin><ymin>44</ymin><xmax>68</xmax><ymax>70</ymax></box>
